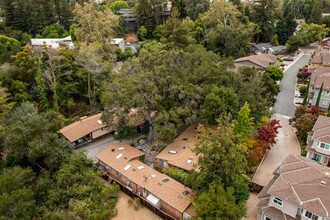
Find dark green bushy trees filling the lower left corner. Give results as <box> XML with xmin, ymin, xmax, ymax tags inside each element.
<box><xmin>0</xmin><ymin>102</ymin><xmax>119</xmax><ymax>219</ymax></box>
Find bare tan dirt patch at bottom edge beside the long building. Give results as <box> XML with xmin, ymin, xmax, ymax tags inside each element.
<box><xmin>111</xmin><ymin>191</ymin><xmax>161</xmax><ymax>220</ymax></box>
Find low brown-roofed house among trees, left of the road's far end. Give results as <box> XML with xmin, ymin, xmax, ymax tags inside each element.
<box><xmin>234</xmin><ymin>54</ymin><xmax>279</xmax><ymax>70</ymax></box>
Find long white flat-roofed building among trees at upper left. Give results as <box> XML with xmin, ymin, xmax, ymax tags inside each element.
<box><xmin>31</xmin><ymin>36</ymin><xmax>74</xmax><ymax>49</ymax></box>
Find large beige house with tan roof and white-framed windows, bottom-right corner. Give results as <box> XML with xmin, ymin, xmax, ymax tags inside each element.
<box><xmin>257</xmin><ymin>155</ymin><xmax>330</xmax><ymax>220</ymax></box>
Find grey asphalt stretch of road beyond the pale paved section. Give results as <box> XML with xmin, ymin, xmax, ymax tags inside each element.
<box><xmin>273</xmin><ymin>53</ymin><xmax>310</xmax><ymax>117</ymax></box>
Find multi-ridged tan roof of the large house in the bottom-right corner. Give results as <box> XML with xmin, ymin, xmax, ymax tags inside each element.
<box><xmin>258</xmin><ymin>155</ymin><xmax>330</xmax><ymax>217</ymax></box>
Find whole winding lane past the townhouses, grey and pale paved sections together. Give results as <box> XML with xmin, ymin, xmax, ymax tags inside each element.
<box><xmin>246</xmin><ymin>47</ymin><xmax>315</xmax><ymax>220</ymax></box>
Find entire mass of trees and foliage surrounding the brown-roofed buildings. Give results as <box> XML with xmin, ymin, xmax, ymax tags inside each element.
<box><xmin>0</xmin><ymin>0</ymin><xmax>320</xmax><ymax>219</ymax></box>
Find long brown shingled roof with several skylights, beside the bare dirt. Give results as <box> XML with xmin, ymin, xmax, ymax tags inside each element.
<box><xmin>96</xmin><ymin>143</ymin><xmax>195</xmax><ymax>212</ymax></box>
